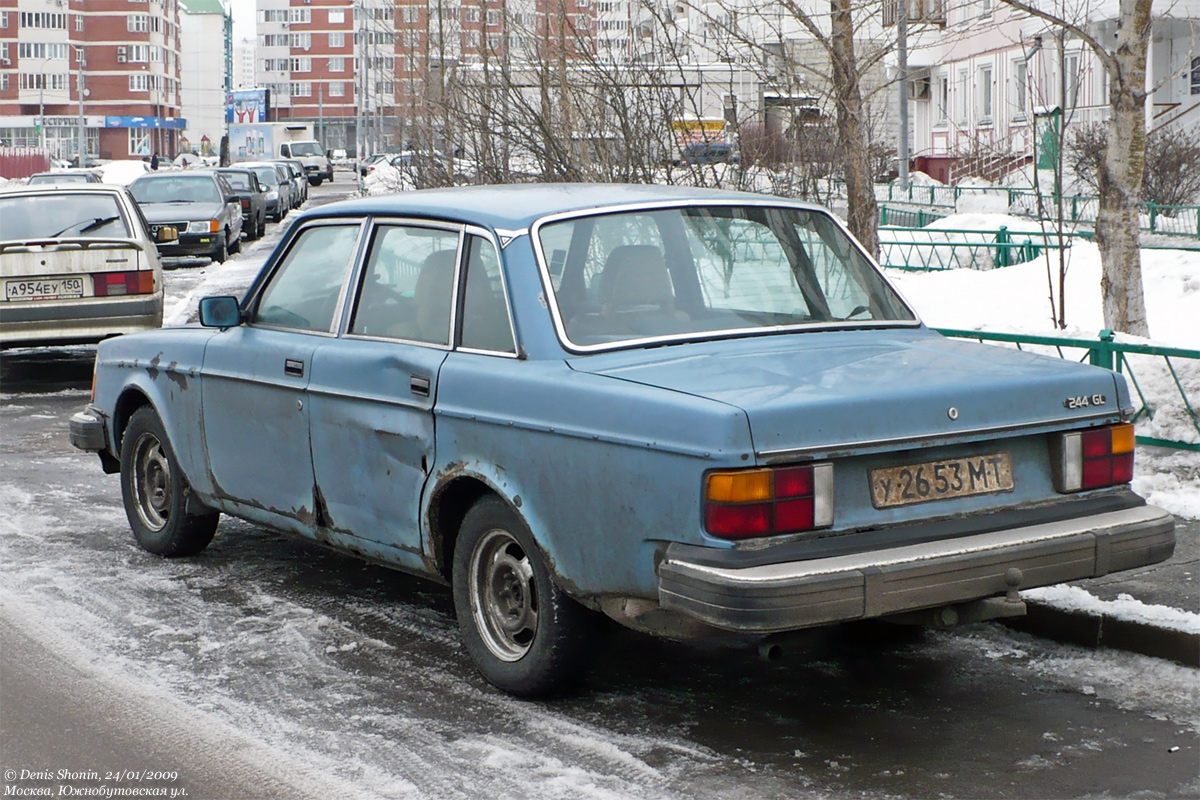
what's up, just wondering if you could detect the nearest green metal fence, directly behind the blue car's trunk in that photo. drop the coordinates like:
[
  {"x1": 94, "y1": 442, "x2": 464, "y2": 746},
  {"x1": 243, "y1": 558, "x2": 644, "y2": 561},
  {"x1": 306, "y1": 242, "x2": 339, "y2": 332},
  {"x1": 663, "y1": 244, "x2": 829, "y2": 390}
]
[{"x1": 937, "y1": 327, "x2": 1200, "y2": 452}]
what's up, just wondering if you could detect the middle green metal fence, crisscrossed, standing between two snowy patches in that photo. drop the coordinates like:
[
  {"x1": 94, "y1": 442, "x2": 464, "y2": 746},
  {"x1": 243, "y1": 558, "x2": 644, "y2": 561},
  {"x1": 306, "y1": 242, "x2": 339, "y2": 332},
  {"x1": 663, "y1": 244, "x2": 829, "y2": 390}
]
[{"x1": 880, "y1": 225, "x2": 1078, "y2": 272}]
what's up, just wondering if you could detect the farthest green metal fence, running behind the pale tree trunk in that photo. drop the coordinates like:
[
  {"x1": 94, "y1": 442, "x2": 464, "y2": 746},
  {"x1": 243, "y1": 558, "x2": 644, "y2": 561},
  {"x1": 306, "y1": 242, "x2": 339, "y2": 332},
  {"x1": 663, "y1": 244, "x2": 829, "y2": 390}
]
[{"x1": 854, "y1": 181, "x2": 1200, "y2": 239}]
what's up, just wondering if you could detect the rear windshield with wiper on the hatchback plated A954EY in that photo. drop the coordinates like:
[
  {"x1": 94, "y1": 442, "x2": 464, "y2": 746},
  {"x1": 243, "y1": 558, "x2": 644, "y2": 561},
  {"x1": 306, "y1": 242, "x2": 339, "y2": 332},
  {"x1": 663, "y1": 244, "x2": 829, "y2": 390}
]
[{"x1": 0, "y1": 193, "x2": 130, "y2": 240}]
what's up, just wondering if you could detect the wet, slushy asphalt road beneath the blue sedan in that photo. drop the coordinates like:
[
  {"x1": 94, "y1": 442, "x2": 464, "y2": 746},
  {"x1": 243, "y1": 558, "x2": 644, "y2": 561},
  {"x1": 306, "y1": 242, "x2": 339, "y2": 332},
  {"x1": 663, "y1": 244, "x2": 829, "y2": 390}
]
[{"x1": 0, "y1": 175, "x2": 1200, "y2": 800}]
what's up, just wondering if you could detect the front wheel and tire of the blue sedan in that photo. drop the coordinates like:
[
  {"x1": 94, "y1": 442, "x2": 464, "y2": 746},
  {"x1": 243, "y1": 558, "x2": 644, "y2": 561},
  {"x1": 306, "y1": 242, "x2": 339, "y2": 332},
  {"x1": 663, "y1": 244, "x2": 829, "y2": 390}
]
[{"x1": 121, "y1": 405, "x2": 221, "y2": 558}]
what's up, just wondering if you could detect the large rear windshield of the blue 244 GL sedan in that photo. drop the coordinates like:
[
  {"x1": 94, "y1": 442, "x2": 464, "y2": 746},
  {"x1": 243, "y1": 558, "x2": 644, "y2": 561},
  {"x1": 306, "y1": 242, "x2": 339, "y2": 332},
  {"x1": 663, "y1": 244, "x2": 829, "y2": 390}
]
[{"x1": 538, "y1": 205, "x2": 916, "y2": 349}]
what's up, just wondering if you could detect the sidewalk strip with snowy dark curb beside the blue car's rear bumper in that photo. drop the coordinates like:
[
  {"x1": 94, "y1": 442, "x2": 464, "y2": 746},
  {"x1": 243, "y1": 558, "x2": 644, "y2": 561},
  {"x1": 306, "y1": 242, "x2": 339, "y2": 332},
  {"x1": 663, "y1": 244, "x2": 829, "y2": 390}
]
[{"x1": 1007, "y1": 519, "x2": 1200, "y2": 667}]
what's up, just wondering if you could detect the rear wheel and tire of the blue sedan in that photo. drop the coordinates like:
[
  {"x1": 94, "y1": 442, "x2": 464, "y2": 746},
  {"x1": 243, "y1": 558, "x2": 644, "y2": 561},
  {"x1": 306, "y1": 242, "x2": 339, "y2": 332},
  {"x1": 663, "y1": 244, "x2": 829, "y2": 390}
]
[{"x1": 451, "y1": 497, "x2": 598, "y2": 697}]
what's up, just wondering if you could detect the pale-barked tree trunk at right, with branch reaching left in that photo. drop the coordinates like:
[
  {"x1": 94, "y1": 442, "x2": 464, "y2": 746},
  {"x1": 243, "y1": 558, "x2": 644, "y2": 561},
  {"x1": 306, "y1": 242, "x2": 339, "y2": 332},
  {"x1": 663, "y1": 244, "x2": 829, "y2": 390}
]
[{"x1": 1001, "y1": 0, "x2": 1153, "y2": 336}]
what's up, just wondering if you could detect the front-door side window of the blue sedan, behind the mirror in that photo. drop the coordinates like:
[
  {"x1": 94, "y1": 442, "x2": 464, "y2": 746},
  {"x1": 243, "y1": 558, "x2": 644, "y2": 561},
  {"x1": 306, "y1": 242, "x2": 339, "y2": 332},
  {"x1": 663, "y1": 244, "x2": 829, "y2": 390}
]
[{"x1": 252, "y1": 224, "x2": 359, "y2": 332}]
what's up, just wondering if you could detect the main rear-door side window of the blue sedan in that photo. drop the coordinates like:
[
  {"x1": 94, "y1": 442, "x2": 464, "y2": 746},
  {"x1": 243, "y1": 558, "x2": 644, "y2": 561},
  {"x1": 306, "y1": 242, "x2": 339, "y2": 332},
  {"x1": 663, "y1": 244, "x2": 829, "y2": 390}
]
[{"x1": 349, "y1": 225, "x2": 458, "y2": 345}]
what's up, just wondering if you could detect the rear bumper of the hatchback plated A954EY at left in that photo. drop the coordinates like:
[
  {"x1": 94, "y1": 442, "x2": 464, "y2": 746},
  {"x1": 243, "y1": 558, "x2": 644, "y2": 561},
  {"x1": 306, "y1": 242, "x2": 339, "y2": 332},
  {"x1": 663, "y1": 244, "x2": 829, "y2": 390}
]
[{"x1": 0, "y1": 293, "x2": 162, "y2": 347}]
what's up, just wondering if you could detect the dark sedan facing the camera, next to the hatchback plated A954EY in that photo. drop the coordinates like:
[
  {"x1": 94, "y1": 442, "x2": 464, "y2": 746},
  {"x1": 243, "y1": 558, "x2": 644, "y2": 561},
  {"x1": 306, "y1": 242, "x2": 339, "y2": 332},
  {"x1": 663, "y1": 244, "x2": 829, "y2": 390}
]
[{"x1": 130, "y1": 169, "x2": 242, "y2": 264}]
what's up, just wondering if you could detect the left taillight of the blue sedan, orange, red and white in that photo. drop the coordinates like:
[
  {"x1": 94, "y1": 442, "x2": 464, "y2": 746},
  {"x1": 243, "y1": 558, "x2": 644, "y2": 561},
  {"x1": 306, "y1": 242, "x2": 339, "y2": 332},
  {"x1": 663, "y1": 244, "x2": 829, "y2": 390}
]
[{"x1": 704, "y1": 463, "x2": 833, "y2": 539}]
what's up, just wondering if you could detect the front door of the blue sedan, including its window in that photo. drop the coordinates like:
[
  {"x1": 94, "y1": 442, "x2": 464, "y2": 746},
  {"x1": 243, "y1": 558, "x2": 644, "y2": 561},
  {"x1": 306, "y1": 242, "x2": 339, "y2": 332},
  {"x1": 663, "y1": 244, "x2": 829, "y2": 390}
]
[{"x1": 202, "y1": 219, "x2": 361, "y2": 533}]
